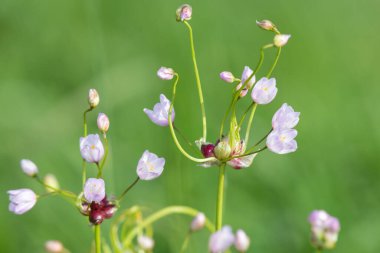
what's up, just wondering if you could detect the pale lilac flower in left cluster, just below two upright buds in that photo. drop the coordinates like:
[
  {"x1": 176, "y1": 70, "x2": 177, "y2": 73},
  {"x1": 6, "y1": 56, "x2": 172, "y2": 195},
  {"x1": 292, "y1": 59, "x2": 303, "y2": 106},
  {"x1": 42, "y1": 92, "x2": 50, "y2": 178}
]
[{"x1": 79, "y1": 134, "x2": 104, "y2": 163}]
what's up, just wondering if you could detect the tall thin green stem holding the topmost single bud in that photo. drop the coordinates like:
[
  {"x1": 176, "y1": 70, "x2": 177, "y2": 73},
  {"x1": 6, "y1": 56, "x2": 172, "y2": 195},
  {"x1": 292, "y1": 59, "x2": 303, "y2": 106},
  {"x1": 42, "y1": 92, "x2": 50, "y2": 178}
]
[{"x1": 183, "y1": 20, "x2": 207, "y2": 140}]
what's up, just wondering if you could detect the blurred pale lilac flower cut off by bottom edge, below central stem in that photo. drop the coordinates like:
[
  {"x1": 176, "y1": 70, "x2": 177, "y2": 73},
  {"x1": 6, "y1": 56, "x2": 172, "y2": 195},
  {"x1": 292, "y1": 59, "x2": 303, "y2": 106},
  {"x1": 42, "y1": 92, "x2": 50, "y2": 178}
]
[{"x1": 208, "y1": 226, "x2": 235, "y2": 253}]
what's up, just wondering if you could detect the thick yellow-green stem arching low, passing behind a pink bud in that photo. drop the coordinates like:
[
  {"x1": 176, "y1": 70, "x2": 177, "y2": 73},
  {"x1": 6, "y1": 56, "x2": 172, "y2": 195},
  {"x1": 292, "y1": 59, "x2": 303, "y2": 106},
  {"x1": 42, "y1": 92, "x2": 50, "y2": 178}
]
[{"x1": 123, "y1": 206, "x2": 214, "y2": 248}]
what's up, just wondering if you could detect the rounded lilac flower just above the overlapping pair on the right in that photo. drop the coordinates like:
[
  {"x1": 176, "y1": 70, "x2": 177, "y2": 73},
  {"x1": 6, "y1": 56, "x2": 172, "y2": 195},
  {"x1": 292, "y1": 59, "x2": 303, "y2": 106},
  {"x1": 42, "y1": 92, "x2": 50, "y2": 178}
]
[{"x1": 251, "y1": 77, "x2": 277, "y2": 105}]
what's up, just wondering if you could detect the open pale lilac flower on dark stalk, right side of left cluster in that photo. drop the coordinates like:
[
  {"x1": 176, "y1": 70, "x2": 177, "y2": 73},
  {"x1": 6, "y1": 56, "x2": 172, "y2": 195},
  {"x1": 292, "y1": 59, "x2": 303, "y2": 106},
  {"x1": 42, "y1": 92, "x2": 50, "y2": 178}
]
[{"x1": 137, "y1": 150, "x2": 165, "y2": 180}]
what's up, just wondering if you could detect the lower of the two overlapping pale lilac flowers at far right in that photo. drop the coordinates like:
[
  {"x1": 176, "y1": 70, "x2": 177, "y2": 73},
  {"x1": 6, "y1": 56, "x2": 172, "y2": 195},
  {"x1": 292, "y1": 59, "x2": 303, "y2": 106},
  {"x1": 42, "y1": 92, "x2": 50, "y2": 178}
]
[{"x1": 267, "y1": 129, "x2": 297, "y2": 154}]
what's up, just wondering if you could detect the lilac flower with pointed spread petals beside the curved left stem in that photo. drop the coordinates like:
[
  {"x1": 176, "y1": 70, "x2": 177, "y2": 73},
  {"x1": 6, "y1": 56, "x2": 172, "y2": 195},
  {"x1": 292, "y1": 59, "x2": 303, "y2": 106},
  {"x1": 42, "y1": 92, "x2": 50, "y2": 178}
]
[{"x1": 144, "y1": 94, "x2": 175, "y2": 126}]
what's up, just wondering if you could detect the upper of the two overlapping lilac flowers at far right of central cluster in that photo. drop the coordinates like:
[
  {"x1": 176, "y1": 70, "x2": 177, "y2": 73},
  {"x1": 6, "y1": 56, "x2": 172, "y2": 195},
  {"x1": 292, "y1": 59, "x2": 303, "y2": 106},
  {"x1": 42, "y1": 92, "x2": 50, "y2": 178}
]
[{"x1": 272, "y1": 103, "x2": 300, "y2": 130}]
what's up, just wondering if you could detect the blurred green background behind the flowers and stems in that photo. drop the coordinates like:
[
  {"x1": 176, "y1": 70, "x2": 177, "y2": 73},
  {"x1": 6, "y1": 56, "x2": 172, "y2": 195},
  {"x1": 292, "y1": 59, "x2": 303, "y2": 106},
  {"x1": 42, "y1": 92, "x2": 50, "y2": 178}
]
[{"x1": 0, "y1": 0, "x2": 380, "y2": 253}]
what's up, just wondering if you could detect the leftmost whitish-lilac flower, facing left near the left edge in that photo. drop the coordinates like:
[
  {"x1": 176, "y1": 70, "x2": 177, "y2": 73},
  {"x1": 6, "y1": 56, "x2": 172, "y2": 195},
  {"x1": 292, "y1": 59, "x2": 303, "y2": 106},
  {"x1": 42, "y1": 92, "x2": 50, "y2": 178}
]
[{"x1": 8, "y1": 189, "x2": 37, "y2": 214}]
